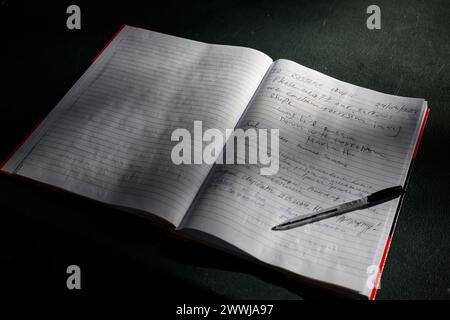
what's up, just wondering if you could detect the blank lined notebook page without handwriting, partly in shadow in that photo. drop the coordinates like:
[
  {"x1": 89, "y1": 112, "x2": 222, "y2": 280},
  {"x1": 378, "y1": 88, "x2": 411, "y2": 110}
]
[{"x1": 6, "y1": 27, "x2": 272, "y2": 226}]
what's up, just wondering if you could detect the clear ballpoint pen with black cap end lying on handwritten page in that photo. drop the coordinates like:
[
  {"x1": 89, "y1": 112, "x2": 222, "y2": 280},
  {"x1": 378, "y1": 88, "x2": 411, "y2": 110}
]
[{"x1": 272, "y1": 186, "x2": 405, "y2": 231}]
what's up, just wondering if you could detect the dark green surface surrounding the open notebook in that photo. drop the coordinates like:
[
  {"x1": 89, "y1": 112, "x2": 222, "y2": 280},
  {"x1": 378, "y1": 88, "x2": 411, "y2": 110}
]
[{"x1": 0, "y1": 0, "x2": 450, "y2": 299}]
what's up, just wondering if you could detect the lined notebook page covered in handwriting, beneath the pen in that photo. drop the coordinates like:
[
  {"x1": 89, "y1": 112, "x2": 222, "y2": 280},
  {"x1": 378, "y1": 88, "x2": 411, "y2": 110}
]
[{"x1": 185, "y1": 60, "x2": 425, "y2": 296}]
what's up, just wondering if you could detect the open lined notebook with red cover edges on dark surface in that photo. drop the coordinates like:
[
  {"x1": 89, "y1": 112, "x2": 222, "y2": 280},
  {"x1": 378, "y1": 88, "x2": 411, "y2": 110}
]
[{"x1": 2, "y1": 26, "x2": 429, "y2": 298}]
